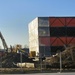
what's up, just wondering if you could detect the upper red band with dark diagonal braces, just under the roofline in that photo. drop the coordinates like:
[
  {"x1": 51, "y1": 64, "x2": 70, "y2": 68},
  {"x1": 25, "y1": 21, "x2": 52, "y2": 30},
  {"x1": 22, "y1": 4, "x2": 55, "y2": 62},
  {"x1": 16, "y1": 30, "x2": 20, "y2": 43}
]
[{"x1": 49, "y1": 17, "x2": 75, "y2": 27}]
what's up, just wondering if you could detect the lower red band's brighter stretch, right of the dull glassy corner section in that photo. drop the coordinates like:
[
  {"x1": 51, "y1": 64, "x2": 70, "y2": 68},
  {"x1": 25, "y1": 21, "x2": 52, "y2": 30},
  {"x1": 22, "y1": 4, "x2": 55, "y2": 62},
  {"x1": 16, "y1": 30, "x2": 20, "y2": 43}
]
[{"x1": 50, "y1": 37, "x2": 75, "y2": 46}]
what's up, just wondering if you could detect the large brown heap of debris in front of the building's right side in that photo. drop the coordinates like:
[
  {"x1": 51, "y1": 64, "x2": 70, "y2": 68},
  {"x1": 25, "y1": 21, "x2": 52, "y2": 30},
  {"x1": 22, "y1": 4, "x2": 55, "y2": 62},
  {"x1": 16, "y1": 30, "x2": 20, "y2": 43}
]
[{"x1": 46, "y1": 45, "x2": 75, "y2": 68}]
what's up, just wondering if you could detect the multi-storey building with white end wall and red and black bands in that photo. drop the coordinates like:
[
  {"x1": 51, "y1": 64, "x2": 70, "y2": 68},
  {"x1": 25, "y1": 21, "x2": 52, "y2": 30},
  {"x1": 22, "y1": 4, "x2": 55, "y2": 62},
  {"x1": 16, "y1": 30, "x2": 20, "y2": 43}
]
[{"x1": 29, "y1": 17, "x2": 75, "y2": 56}]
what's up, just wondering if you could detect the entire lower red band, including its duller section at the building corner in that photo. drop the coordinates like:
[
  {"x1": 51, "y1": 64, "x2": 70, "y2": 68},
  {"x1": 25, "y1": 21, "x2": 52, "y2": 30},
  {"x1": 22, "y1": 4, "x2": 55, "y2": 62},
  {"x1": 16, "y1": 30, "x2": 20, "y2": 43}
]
[{"x1": 39, "y1": 37, "x2": 75, "y2": 46}]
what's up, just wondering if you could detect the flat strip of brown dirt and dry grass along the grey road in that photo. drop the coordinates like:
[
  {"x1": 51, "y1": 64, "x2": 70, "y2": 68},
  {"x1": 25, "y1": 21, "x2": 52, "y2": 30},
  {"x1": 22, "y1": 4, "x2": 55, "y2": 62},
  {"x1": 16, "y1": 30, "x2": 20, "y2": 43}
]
[{"x1": 0, "y1": 68, "x2": 75, "y2": 74}]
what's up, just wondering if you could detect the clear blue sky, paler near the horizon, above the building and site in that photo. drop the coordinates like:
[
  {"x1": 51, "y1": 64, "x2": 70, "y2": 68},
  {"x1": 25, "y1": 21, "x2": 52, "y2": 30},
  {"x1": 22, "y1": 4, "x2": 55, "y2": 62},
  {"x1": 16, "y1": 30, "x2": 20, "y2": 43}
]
[{"x1": 0, "y1": 0, "x2": 75, "y2": 46}]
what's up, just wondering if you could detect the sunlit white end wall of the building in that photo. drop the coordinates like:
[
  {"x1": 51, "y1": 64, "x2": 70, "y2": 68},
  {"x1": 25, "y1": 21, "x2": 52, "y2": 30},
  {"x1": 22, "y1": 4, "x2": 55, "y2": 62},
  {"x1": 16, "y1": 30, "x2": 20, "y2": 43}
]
[{"x1": 29, "y1": 18, "x2": 39, "y2": 53}]
